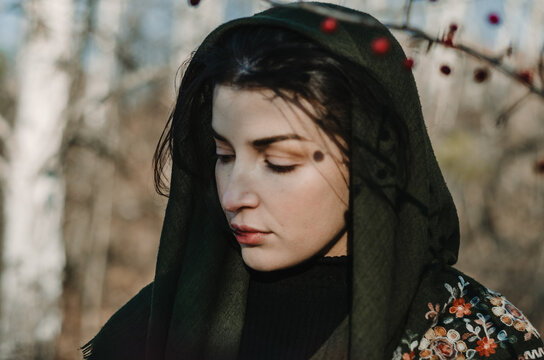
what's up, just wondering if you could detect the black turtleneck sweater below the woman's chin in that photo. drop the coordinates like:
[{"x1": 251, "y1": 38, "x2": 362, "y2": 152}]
[{"x1": 239, "y1": 255, "x2": 351, "y2": 360}]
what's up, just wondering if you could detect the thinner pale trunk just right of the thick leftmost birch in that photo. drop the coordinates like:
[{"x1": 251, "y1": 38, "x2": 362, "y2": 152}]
[{"x1": 78, "y1": 0, "x2": 125, "y2": 339}]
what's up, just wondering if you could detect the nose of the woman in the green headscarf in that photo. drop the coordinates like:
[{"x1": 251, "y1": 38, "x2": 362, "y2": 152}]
[{"x1": 221, "y1": 161, "x2": 259, "y2": 213}]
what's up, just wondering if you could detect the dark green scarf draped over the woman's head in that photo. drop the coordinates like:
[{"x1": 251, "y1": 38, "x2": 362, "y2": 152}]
[{"x1": 85, "y1": 3, "x2": 459, "y2": 360}]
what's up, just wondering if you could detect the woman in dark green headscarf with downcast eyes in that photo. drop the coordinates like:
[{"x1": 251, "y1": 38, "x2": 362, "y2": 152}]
[{"x1": 84, "y1": 4, "x2": 544, "y2": 360}]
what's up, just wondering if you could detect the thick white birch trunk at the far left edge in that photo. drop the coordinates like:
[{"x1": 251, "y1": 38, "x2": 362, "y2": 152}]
[{"x1": 0, "y1": 0, "x2": 73, "y2": 359}]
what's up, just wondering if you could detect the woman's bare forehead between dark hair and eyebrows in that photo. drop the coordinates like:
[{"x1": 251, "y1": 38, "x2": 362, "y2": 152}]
[{"x1": 212, "y1": 85, "x2": 323, "y2": 142}]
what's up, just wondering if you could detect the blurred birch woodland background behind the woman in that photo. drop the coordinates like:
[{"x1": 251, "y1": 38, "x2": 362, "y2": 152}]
[{"x1": 0, "y1": 0, "x2": 544, "y2": 360}]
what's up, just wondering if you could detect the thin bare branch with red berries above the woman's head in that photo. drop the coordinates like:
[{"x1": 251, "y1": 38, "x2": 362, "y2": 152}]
[{"x1": 264, "y1": 0, "x2": 544, "y2": 99}]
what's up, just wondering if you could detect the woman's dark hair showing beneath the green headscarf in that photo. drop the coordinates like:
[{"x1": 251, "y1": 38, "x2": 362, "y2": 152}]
[{"x1": 154, "y1": 26, "x2": 407, "y2": 200}]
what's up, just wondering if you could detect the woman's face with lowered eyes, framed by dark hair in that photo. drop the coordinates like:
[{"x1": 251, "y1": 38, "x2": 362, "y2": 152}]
[{"x1": 212, "y1": 85, "x2": 349, "y2": 271}]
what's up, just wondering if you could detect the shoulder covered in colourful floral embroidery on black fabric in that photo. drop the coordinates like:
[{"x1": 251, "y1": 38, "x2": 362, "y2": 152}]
[{"x1": 394, "y1": 273, "x2": 544, "y2": 360}]
